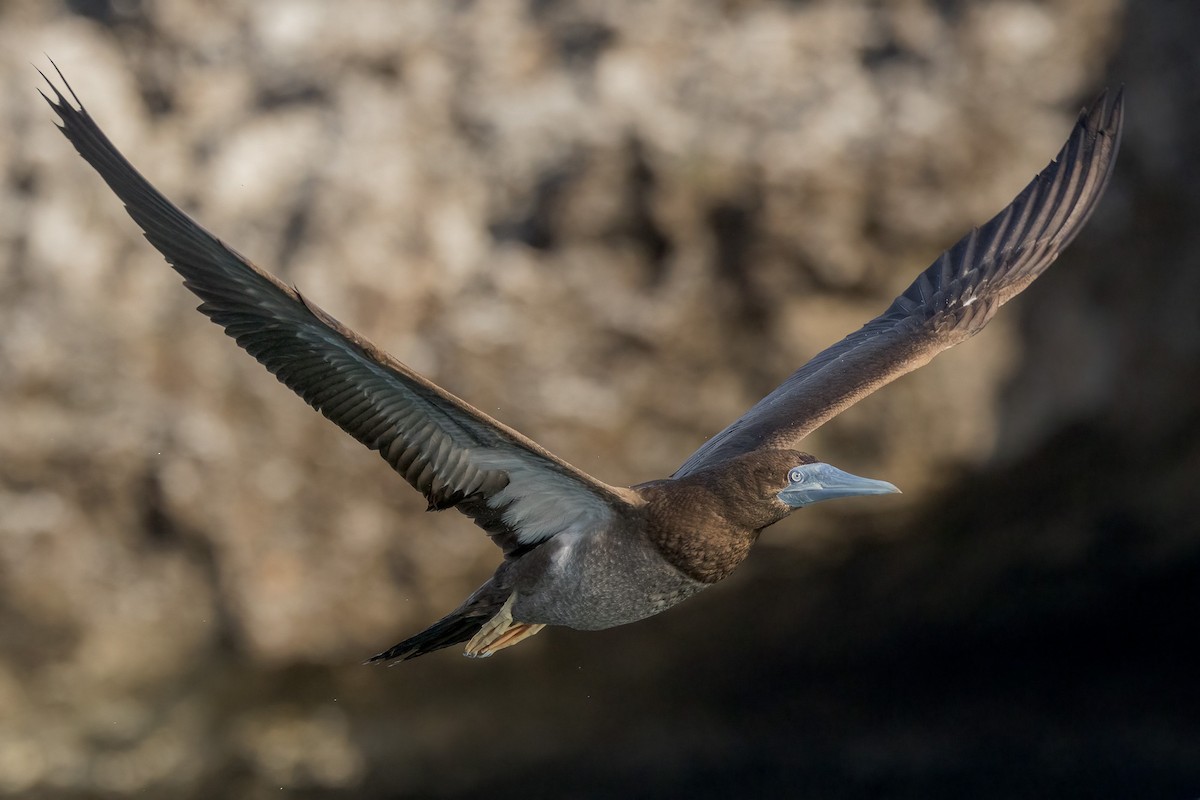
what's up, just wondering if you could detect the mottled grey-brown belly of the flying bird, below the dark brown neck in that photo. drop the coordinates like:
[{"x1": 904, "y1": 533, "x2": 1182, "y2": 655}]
[{"x1": 512, "y1": 534, "x2": 709, "y2": 631}]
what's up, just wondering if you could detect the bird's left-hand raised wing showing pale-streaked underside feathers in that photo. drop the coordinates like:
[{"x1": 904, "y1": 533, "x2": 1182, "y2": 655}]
[{"x1": 42, "y1": 66, "x2": 631, "y2": 555}]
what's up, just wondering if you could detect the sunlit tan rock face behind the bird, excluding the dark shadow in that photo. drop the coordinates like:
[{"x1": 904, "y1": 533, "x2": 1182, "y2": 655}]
[{"x1": 9, "y1": 0, "x2": 1195, "y2": 796}]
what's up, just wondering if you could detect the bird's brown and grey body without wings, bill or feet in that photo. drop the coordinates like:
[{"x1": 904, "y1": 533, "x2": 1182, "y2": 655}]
[{"x1": 378, "y1": 450, "x2": 806, "y2": 660}]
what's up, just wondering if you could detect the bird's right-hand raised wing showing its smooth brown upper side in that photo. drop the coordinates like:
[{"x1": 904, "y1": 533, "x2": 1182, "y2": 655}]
[{"x1": 674, "y1": 91, "x2": 1123, "y2": 477}]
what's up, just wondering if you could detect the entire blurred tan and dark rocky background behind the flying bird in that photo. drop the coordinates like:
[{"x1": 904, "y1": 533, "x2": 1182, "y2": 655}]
[{"x1": 0, "y1": 0, "x2": 1200, "y2": 799}]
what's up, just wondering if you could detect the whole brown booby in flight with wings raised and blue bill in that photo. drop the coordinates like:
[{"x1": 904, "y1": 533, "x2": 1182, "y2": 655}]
[{"x1": 42, "y1": 67, "x2": 1123, "y2": 662}]
